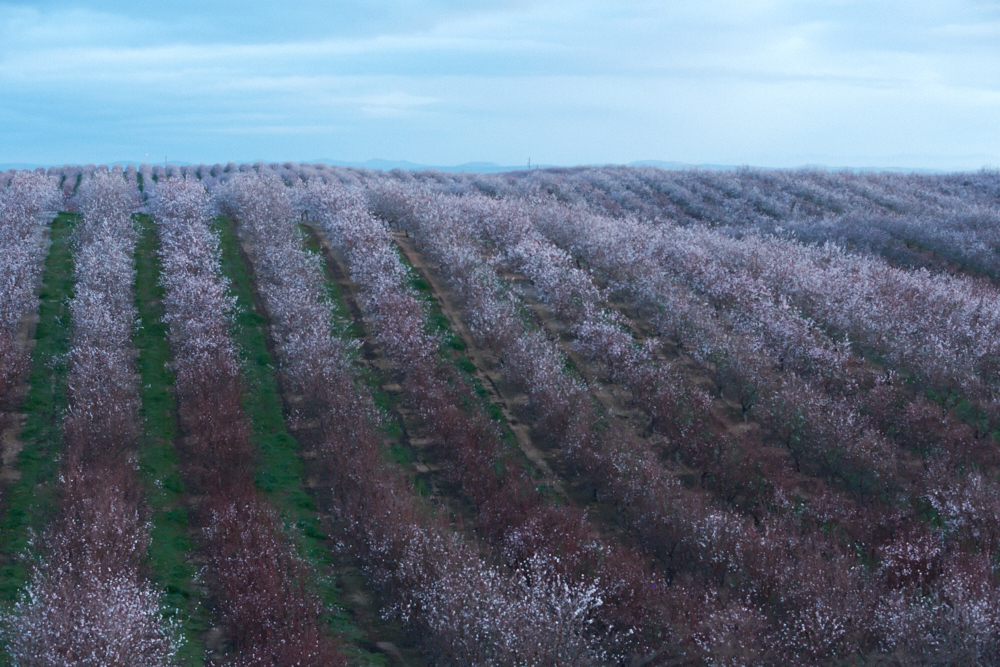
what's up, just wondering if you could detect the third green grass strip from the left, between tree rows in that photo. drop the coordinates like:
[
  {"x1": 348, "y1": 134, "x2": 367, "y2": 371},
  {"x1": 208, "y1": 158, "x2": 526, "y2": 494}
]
[{"x1": 214, "y1": 217, "x2": 383, "y2": 664}]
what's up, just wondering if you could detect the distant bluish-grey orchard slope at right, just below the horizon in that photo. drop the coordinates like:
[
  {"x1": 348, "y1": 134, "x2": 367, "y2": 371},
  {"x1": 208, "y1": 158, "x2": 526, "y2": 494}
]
[{"x1": 516, "y1": 168, "x2": 1000, "y2": 277}]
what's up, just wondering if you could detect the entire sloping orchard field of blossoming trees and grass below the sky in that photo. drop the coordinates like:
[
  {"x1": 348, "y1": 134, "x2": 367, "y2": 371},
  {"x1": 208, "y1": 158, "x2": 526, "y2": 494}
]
[{"x1": 0, "y1": 163, "x2": 1000, "y2": 666}]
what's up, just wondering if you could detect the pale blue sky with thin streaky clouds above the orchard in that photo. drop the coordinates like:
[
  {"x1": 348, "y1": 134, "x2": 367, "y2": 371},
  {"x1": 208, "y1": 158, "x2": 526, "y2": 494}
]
[{"x1": 0, "y1": 0, "x2": 1000, "y2": 170}]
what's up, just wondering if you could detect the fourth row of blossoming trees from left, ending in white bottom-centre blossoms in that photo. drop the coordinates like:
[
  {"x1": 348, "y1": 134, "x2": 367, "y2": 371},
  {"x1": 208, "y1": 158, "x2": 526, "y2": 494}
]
[{"x1": 221, "y1": 177, "x2": 632, "y2": 665}]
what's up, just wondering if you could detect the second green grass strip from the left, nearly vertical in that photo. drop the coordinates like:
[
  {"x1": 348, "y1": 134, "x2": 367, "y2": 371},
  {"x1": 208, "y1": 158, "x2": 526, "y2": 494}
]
[{"x1": 133, "y1": 215, "x2": 208, "y2": 666}]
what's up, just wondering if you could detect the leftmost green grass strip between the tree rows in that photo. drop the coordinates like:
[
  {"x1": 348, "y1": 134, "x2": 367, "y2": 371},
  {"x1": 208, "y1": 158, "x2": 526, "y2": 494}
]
[{"x1": 0, "y1": 213, "x2": 80, "y2": 664}]
